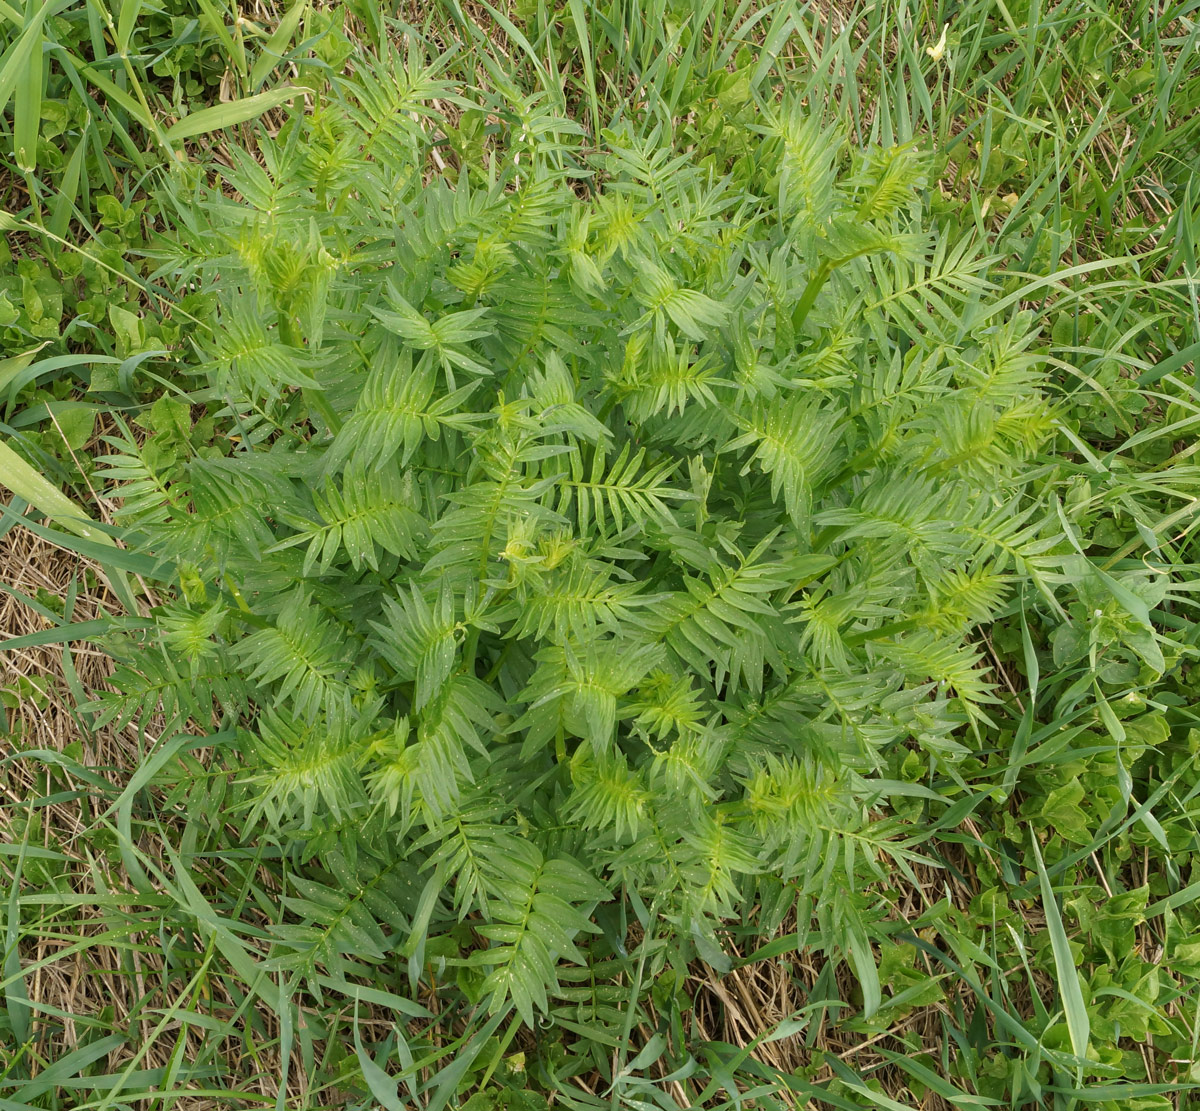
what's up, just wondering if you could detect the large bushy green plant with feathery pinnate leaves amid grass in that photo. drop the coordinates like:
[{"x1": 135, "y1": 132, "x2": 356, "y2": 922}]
[{"x1": 98, "y1": 41, "x2": 1080, "y2": 1069}]
